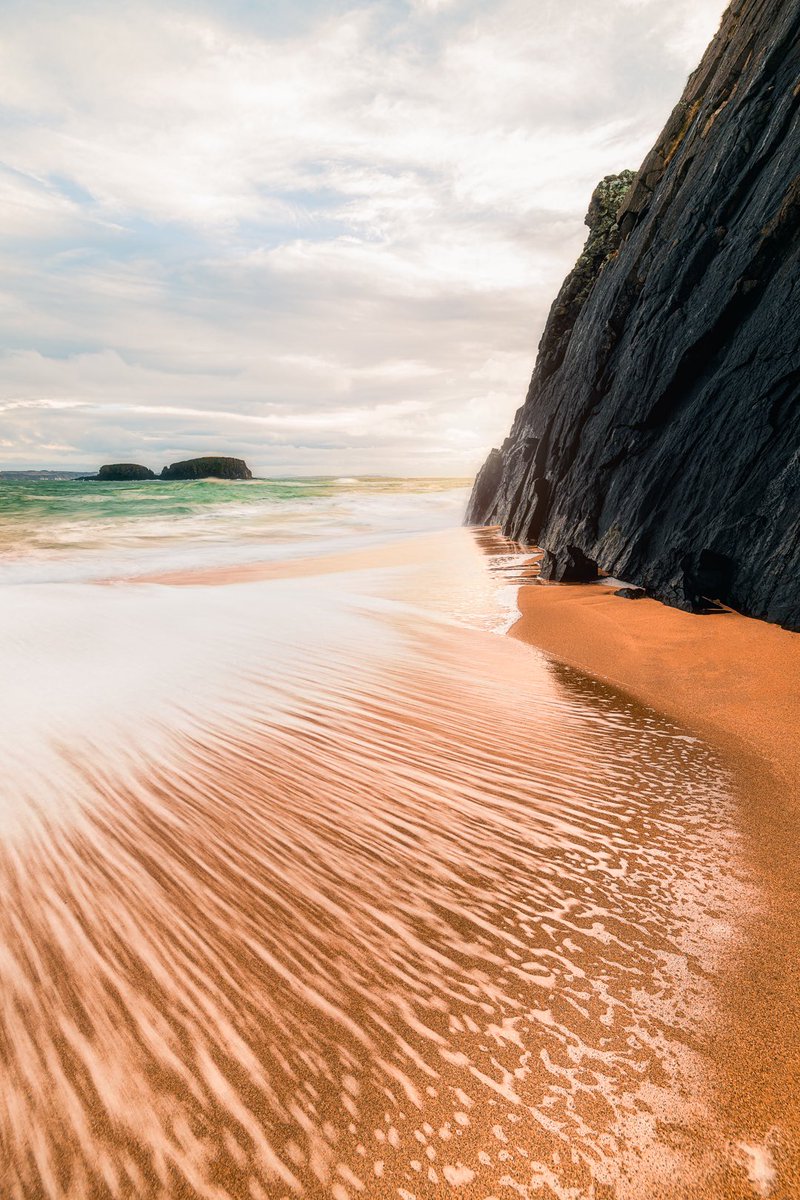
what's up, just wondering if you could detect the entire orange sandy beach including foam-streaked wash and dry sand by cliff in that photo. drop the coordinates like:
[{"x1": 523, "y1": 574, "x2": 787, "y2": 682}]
[{"x1": 0, "y1": 489, "x2": 798, "y2": 1200}]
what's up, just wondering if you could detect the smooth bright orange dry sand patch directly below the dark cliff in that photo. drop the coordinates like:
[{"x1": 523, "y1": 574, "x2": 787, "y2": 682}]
[{"x1": 512, "y1": 582, "x2": 800, "y2": 800}]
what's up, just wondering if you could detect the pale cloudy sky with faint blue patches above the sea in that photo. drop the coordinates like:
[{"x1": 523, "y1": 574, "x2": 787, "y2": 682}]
[{"x1": 0, "y1": 0, "x2": 724, "y2": 475}]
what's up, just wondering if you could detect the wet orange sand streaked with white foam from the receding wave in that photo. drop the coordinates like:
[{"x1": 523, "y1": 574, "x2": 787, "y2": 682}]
[{"x1": 0, "y1": 540, "x2": 753, "y2": 1200}]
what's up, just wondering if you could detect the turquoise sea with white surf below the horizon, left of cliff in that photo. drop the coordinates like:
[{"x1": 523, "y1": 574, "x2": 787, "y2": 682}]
[{"x1": 0, "y1": 476, "x2": 469, "y2": 583}]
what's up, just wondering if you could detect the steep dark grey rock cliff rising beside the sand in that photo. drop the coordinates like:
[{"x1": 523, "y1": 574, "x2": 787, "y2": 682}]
[{"x1": 467, "y1": 0, "x2": 800, "y2": 630}]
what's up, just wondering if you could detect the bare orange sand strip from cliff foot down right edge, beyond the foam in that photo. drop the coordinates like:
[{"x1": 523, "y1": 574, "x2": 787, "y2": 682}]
[{"x1": 509, "y1": 581, "x2": 800, "y2": 1196}]
